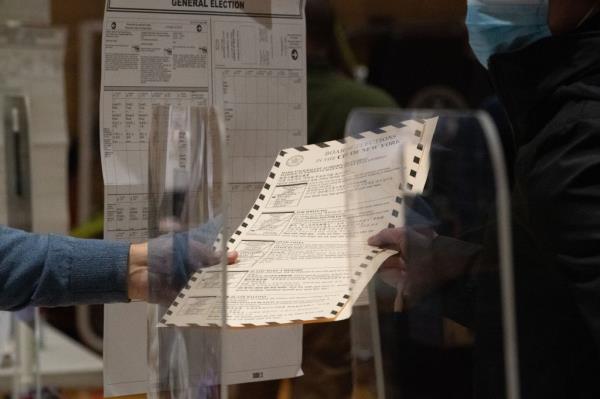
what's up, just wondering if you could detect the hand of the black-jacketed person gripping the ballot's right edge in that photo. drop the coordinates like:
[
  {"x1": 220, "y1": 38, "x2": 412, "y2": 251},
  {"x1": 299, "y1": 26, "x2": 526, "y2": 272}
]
[{"x1": 368, "y1": 226, "x2": 438, "y2": 312}]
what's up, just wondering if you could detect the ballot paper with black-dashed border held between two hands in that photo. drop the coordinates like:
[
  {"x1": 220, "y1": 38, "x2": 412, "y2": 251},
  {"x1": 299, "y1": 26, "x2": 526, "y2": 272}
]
[{"x1": 161, "y1": 118, "x2": 437, "y2": 327}]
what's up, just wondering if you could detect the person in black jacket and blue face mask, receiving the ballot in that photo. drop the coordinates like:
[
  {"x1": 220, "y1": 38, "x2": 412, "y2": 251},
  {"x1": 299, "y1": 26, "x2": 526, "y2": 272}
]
[{"x1": 370, "y1": 0, "x2": 600, "y2": 399}]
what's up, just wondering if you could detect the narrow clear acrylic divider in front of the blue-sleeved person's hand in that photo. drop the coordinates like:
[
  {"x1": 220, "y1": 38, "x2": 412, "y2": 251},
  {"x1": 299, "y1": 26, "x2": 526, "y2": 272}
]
[{"x1": 148, "y1": 106, "x2": 229, "y2": 399}]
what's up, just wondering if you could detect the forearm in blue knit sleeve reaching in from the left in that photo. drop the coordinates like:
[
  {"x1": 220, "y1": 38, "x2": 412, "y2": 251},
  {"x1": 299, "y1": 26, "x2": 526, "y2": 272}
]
[{"x1": 0, "y1": 226, "x2": 129, "y2": 310}]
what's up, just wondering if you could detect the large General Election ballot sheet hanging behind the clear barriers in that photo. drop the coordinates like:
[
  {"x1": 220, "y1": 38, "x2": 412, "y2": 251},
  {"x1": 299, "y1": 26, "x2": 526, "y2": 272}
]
[{"x1": 100, "y1": 0, "x2": 307, "y2": 396}]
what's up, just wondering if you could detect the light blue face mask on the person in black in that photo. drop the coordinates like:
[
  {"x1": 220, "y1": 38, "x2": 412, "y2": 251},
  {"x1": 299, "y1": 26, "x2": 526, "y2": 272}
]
[{"x1": 466, "y1": 0, "x2": 551, "y2": 67}]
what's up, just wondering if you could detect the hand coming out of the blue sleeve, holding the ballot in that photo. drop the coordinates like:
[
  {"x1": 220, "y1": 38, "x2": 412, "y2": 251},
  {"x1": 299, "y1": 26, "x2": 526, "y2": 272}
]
[{"x1": 127, "y1": 237, "x2": 238, "y2": 301}]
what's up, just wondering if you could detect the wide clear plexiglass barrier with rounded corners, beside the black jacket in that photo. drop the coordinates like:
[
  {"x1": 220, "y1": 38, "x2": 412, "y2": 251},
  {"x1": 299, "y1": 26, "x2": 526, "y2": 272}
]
[{"x1": 346, "y1": 109, "x2": 519, "y2": 399}]
